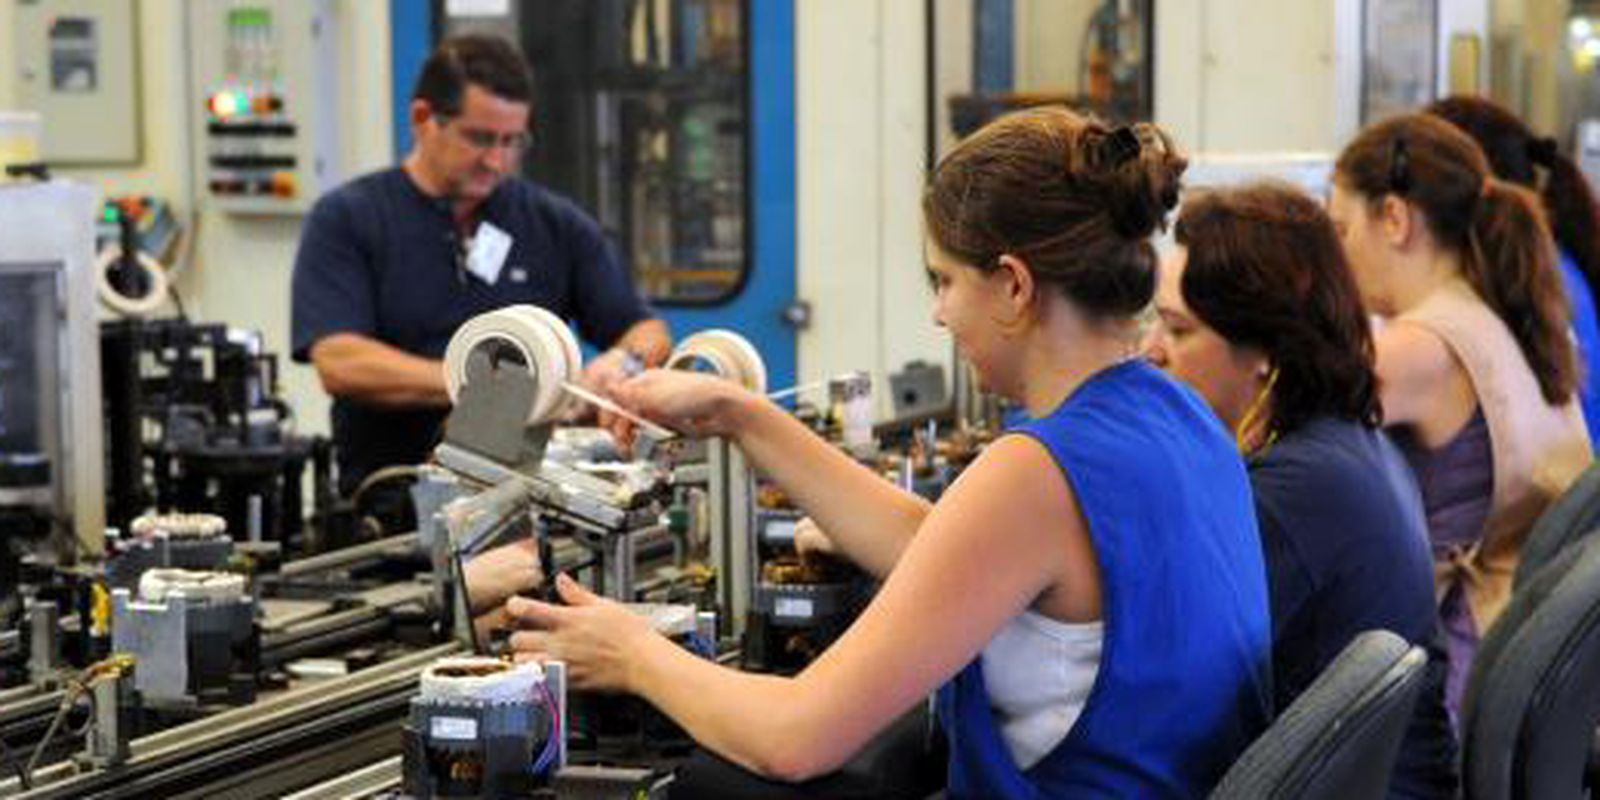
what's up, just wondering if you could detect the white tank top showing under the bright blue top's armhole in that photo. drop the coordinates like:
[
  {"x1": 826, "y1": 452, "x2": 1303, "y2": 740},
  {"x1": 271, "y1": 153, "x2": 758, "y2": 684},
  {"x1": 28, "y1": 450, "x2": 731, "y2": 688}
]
[{"x1": 982, "y1": 611, "x2": 1104, "y2": 770}]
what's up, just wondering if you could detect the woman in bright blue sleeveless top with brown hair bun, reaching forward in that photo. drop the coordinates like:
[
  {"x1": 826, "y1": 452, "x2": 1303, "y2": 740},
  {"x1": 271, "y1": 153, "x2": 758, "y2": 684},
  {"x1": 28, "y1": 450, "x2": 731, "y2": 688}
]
[{"x1": 509, "y1": 109, "x2": 1270, "y2": 798}]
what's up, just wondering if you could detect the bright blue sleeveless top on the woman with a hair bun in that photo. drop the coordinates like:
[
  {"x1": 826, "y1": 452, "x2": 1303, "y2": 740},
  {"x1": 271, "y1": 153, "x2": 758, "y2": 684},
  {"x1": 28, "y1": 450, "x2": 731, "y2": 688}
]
[{"x1": 938, "y1": 362, "x2": 1272, "y2": 798}]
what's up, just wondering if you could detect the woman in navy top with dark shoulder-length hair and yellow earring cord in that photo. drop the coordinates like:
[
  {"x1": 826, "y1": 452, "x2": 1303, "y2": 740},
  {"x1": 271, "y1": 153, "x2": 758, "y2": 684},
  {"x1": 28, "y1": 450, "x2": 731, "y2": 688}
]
[{"x1": 1150, "y1": 184, "x2": 1456, "y2": 797}]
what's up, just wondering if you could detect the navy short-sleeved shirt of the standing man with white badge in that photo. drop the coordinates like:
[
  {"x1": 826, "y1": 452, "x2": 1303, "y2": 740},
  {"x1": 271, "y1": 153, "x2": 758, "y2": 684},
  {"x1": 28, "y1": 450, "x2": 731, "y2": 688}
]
[{"x1": 293, "y1": 166, "x2": 650, "y2": 491}]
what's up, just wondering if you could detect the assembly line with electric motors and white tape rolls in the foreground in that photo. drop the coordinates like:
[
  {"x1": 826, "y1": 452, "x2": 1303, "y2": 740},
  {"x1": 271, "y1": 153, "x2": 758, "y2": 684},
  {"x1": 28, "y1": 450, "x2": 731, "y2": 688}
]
[{"x1": 0, "y1": 292, "x2": 972, "y2": 798}]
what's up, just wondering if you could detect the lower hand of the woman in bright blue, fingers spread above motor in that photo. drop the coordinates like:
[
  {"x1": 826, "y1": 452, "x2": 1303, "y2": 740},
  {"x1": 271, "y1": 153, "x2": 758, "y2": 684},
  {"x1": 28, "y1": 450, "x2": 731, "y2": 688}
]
[{"x1": 506, "y1": 574, "x2": 658, "y2": 691}]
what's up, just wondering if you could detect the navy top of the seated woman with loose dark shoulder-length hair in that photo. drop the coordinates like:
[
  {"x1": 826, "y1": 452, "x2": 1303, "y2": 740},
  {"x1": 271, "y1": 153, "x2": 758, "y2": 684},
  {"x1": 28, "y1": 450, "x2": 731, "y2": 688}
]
[{"x1": 1250, "y1": 418, "x2": 1456, "y2": 798}]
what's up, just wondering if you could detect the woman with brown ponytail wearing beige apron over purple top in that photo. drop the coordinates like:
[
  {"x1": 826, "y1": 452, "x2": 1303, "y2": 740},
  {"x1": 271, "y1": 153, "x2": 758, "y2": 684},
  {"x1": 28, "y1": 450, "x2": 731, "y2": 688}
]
[{"x1": 1328, "y1": 114, "x2": 1590, "y2": 720}]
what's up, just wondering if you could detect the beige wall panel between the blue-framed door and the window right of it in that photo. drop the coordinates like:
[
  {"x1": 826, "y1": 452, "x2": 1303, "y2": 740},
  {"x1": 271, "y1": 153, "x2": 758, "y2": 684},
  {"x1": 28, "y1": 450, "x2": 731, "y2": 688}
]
[{"x1": 795, "y1": 0, "x2": 952, "y2": 416}]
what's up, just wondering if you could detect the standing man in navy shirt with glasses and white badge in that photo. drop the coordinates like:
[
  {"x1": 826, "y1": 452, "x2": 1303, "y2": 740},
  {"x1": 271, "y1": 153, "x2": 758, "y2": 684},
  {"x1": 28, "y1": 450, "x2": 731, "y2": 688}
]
[{"x1": 293, "y1": 35, "x2": 672, "y2": 494}]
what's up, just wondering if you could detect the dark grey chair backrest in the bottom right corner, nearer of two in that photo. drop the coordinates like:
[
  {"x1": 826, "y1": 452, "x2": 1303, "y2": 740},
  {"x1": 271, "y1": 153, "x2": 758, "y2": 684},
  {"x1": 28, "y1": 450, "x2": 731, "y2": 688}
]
[{"x1": 1461, "y1": 536, "x2": 1600, "y2": 800}]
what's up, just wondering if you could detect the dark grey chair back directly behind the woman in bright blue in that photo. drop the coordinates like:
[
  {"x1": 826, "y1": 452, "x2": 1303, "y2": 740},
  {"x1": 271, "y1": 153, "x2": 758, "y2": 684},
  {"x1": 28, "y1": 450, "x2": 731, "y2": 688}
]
[{"x1": 1211, "y1": 630, "x2": 1427, "y2": 800}]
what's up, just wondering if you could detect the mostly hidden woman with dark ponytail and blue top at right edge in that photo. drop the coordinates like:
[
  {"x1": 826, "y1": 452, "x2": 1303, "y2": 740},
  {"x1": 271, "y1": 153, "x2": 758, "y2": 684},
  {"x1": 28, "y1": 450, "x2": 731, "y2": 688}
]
[{"x1": 1427, "y1": 94, "x2": 1600, "y2": 438}]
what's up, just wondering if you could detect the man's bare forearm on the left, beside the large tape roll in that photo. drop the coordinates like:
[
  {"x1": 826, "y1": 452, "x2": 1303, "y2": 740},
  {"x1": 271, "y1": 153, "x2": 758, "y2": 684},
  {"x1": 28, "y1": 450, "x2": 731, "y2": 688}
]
[{"x1": 310, "y1": 333, "x2": 450, "y2": 408}]
